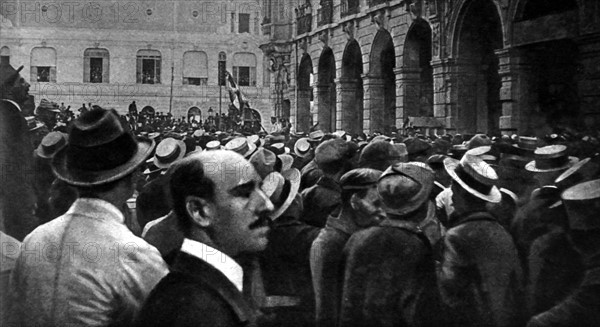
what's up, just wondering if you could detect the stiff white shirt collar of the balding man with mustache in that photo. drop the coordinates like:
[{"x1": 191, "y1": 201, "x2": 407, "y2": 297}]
[{"x1": 181, "y1": 238, "x2": 244, "y2": 292}]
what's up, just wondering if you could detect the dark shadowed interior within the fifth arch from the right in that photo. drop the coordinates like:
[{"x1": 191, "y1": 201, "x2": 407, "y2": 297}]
[{"x1": 342, "y1": 40, "x2": 364, "y2": 133}]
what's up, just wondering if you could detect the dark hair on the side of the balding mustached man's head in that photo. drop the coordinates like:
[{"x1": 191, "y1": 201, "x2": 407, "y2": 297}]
[{"x1": 169, "y1": 157, "x2": 215, "y2": 233}]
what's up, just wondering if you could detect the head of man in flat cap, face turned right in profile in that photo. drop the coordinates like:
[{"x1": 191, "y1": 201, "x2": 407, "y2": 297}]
[{"x1": 340, "y1": 168, "x2": 385, "y2": 227}]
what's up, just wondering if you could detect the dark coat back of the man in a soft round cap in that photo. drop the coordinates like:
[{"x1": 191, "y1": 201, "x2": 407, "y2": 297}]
[{"x1": 339, "y1": 219, "x2": 443, "y2": 326}]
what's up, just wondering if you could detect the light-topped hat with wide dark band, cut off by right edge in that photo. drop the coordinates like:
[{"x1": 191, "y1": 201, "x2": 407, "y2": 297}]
[{"x1": 561, "y1": 179, "x2": 600, "y2": 230}]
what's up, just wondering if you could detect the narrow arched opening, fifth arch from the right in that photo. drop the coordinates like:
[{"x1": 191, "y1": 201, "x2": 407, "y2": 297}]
[{"x1": 341, "y1": 40, "x2": 364, "y2": 134}]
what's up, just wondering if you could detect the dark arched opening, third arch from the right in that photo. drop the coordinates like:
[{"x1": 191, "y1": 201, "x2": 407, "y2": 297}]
[{"x1": 401, "y1": 19, "x2": 433, "y2": 117}]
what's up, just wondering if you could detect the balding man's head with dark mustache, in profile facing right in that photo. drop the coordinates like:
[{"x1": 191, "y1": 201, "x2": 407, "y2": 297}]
[{"x1": 170, "y1": 150, "x2": 273, "y2": 256}]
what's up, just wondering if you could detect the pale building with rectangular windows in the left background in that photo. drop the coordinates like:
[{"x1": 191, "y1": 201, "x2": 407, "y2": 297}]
[{"x1": 0, "y1": 0, "x2": 272, "y2": 124}]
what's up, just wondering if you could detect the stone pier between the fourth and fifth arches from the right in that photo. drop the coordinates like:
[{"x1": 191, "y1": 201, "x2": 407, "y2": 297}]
[{"x1": 362, "y1": 75, "x2": 386, "y2": 133}]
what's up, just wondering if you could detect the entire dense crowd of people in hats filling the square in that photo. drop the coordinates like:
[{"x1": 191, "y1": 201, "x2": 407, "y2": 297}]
[{"x1": 0, "y1": 59, "x2": 600, "y2": 327}]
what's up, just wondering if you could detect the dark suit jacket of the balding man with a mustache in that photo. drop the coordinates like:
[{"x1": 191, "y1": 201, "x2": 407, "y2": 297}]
[{"x1": 138, "y1": 251, "x2": 256, "y2": 327}]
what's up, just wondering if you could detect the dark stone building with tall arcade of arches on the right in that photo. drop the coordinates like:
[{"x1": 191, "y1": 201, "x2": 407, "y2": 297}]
[{"x1": 261, "y1": 0, "x2": 600, "y2": 135}]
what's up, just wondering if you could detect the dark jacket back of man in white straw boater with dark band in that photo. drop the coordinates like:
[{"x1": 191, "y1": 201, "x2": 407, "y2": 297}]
[{"x1": 438, "y1": 212, "x2": 524, "y2": 327}]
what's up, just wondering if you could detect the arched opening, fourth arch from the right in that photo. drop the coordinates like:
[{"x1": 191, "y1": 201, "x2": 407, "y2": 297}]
[{"x1": 369, "y1": 30, "x2": 396, "y2": 135}]
